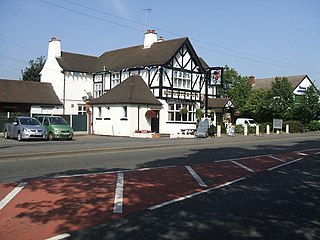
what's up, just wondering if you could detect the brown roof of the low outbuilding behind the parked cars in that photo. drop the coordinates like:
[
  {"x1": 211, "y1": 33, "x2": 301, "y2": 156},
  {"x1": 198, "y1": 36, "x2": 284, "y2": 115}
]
[{"x1": 0, "y1": 79, "x2": 62, "y2": 105}]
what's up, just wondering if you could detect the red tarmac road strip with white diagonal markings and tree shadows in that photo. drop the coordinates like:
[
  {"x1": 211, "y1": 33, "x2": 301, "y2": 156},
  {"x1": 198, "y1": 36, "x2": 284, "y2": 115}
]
[{"x1": 0, "y1": 149, "x2": 320, "y2": 240}]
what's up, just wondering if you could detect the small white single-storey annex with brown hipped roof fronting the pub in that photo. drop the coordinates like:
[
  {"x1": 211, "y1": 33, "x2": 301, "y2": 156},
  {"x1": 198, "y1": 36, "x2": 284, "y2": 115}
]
[{"x1": 91, "y1": 74, "x2": 162, "y2": 136}]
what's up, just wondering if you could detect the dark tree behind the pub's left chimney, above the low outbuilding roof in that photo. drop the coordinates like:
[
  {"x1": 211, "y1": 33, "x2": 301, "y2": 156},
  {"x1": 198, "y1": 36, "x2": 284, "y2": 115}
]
[{"x1": 21, "y1": 56, "x2": 46, "y2": 82}]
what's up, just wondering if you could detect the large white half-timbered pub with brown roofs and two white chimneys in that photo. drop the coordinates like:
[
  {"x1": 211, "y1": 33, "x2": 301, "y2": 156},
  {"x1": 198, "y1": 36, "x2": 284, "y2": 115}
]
[{"x1": 41, "y1": 30, "x2": 216, "y2": 136}]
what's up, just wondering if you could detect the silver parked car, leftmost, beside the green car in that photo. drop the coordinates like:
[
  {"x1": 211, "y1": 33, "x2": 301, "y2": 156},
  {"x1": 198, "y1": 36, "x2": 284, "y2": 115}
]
[{"x1": 3, "y1": 116, "x2": 47, "y2": 141}]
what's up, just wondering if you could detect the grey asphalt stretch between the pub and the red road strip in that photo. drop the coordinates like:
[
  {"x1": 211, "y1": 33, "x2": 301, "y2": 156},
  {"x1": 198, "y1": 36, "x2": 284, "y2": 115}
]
[{"x1": 0, "y1": 132, "x2": 320, "y2": 183}]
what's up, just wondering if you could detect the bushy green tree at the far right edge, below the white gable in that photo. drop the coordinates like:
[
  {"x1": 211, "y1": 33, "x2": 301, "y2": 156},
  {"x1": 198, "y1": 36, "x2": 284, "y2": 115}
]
[{"x1": 293, "y1": 86, "x2": 320, "y2": 125}]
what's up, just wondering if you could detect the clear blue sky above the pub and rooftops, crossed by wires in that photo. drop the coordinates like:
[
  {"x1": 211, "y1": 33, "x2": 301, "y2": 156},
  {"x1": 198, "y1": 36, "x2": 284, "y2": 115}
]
[{"x1": 0, "y1": 0, "x2": 320, "y2": 88}]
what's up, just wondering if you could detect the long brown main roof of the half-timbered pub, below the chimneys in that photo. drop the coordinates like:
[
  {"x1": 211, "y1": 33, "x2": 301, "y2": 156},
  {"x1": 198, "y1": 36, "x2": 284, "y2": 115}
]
[{"x1": 57, "y1": 37, "x2": 207, "y2": 73}]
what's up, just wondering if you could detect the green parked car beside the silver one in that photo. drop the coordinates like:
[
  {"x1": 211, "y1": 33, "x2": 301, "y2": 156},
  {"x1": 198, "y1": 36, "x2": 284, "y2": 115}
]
[{"x1": 36, "y1": 116, "x2": 73, "y2": 141}]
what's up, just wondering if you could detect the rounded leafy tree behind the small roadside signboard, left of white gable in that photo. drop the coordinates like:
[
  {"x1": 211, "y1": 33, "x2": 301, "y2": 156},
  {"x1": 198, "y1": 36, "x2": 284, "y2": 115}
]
[{"x1": 264, "y1": 78, "x2": 294, "y2": 121}]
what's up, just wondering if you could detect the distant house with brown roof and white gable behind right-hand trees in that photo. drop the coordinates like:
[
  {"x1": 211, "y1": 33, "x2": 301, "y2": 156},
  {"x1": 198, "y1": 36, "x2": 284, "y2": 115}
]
[{"x1": 248, "y1": 75, "x2": 317, "y2": 96}]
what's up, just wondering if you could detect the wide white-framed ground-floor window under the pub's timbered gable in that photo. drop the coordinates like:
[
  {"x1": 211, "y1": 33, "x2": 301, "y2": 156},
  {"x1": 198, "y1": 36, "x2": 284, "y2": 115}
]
[{"x1": 168, "y1": 104, "x2": 195, "y2": 122}]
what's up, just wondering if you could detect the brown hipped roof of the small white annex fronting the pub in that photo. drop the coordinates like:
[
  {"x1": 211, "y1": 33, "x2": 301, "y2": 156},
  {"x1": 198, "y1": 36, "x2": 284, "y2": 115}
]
[{"x1": 92, "y1": 75, "x2": 162, "y2": 105}]
